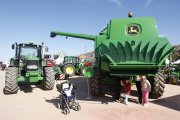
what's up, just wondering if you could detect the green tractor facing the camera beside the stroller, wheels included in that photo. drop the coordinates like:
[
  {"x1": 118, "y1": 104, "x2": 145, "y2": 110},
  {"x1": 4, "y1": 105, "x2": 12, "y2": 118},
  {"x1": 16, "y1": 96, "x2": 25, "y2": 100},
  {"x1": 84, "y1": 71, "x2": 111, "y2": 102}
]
[{"x1": 4, "y1": 42, "x2": 55, "y2": 94}]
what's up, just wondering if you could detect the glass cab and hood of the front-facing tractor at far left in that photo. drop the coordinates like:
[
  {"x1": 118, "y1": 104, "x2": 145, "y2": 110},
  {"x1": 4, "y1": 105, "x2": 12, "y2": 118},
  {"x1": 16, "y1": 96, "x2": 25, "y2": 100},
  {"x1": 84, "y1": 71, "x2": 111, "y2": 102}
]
[{"x1": 10, "y1": 42, "x2": 42, "y2": 71}]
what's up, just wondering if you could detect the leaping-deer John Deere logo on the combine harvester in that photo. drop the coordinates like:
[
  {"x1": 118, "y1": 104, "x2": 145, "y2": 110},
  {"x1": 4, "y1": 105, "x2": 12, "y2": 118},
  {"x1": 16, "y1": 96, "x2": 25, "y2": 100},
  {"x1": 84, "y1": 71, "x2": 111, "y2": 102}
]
[{"x1": 127, "y1": 25, "x2": 141, "y2": 35}]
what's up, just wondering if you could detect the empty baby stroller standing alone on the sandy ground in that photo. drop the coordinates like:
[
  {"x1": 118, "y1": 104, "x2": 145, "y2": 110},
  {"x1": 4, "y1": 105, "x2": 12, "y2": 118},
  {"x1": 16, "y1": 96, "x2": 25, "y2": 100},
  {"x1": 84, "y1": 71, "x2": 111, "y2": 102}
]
[{"x1": 56, "y1": 81, "x2": 81, "y2": 115}]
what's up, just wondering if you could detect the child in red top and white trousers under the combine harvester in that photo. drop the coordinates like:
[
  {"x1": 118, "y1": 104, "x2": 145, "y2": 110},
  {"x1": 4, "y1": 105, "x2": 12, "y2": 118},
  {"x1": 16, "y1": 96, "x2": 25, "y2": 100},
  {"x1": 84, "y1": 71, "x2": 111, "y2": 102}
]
[{"x1": 122, "y1": 80, "x2": 132, "y2": 105}]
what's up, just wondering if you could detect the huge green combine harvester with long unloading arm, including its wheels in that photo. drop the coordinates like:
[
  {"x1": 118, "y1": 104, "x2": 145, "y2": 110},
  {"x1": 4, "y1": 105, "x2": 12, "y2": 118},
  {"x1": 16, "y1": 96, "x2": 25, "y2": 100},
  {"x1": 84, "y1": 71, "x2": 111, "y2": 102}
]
[{"x1": 51, "y1": 13, "x2": 174, "y2": 98}]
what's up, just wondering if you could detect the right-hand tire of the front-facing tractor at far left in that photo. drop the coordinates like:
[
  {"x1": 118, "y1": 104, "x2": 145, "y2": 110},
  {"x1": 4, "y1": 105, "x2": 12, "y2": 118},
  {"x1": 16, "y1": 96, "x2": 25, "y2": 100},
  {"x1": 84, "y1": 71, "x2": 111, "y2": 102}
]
[{"x1": 43, "y1": 67, "x2": 55, "y2": 90}]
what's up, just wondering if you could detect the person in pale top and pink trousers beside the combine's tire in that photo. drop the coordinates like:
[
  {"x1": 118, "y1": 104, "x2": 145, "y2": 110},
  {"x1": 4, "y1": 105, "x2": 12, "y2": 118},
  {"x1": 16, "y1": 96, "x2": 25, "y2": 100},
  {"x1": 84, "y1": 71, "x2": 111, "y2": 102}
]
[{"x1": 141, "y1": 75, "x2": 151, "y2": 106}]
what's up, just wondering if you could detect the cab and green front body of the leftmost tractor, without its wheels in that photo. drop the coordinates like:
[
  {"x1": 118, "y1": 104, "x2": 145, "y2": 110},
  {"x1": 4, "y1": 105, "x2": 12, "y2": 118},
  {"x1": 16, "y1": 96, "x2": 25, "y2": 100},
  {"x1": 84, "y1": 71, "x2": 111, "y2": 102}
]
[{"x1": 10, "y1": 42, "x2": 50, "y2": 83}]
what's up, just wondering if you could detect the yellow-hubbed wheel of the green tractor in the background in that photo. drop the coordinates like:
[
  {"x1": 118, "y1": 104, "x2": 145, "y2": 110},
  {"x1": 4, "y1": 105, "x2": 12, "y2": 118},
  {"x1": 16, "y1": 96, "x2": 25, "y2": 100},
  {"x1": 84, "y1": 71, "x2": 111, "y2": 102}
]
[{"x1": 63, "y1": 64, "x2": 75, "y2": 76}]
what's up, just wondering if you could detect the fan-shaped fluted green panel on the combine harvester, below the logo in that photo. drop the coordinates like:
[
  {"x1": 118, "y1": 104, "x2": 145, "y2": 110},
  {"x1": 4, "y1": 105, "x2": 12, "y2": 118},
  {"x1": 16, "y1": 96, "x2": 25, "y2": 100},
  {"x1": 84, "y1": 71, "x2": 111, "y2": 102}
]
[{"x1": 95, "y1": 38, "x2": 173, "y2": 74}]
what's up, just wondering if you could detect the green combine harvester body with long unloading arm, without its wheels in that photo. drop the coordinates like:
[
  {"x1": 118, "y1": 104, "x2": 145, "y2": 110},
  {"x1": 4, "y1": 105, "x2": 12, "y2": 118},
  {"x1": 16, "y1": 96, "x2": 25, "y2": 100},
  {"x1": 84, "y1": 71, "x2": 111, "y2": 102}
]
[{"x1": 51, "y1": 17, "x2": 174, "y2": 75}]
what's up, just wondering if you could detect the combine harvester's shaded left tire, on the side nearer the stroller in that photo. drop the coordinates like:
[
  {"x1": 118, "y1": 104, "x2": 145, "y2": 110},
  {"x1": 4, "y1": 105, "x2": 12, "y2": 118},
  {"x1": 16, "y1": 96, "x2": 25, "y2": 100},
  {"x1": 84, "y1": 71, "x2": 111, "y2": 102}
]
[{"x1": 90, "y1": 68, "x2": 102, "y2": 96}]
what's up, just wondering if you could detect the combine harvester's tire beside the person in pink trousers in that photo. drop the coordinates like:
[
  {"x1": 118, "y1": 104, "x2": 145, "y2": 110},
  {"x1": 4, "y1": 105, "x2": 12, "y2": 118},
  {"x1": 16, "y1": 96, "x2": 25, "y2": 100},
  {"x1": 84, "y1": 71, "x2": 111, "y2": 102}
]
[{"x1": 150, "y1": 72, "x2": 165, "y2": 99}]
